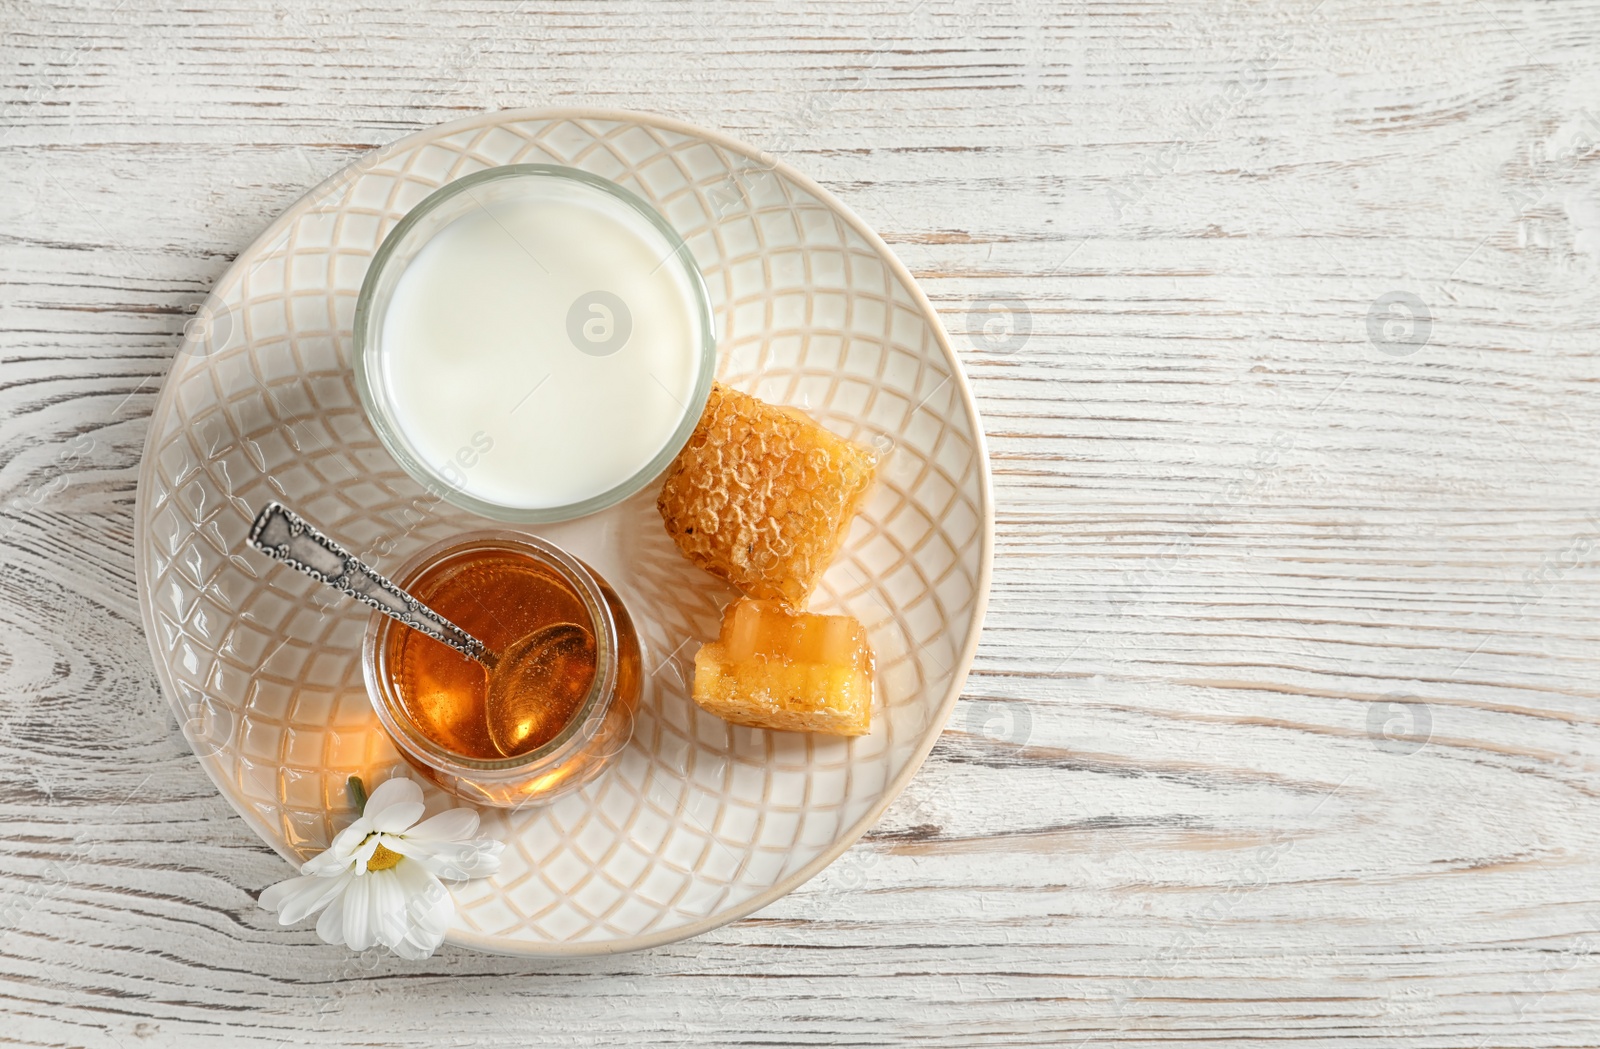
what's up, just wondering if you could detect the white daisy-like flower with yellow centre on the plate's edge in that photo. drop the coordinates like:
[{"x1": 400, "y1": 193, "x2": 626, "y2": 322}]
[{"x1": 261, "y1": 777, "x2": 506, "y2": 959}]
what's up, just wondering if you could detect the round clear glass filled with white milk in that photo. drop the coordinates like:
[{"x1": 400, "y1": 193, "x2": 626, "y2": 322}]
[{"x1": 354, "y1": 165, "x2": 717, "y2": 521}]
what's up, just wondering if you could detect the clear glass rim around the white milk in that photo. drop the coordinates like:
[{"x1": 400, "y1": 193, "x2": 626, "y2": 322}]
[{"x1": 350, "y1": 163, "x2": 717, "y2": 525}]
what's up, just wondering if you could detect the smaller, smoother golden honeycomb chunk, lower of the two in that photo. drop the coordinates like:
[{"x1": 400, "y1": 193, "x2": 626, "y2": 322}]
[{"x1": 694, "y1": 598, "x2": 872, "y2": 736}]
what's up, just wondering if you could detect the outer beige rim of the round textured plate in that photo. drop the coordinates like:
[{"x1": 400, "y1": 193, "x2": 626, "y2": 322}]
[{"x1": 133, "y1": 106, "x2": 995, "y2": 959}]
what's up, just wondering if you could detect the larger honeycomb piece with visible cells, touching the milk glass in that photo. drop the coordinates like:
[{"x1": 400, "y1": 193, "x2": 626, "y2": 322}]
[{"x1": 656, "y1": 382, "x2": 877, "y2": 611}]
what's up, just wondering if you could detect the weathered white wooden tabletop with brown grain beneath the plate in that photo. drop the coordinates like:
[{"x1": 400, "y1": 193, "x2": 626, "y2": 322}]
[{"x1": 0, "y1": 0, "x2": 1600, "y2": 1049}]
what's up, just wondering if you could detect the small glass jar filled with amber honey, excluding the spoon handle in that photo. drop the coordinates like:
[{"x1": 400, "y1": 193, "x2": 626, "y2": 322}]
[{"x1": 362, "y1": 531, "x2": 642, "y2": 808}]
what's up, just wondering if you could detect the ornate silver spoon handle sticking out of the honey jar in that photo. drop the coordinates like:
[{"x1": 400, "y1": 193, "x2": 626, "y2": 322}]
[{"x1": 250, "y1": 502, "x2": 494, "y2": 665}]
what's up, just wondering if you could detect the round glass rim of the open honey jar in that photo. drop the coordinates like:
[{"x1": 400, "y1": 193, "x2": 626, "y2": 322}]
[{"x1": 362, "y1": 529, "x2": 619, "y2": 777}]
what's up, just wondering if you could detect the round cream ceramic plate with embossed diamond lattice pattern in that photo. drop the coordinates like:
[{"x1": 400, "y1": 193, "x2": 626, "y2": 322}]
[{"x1": 136, "y1": 110, "x2": 992, "y2": 956}]
